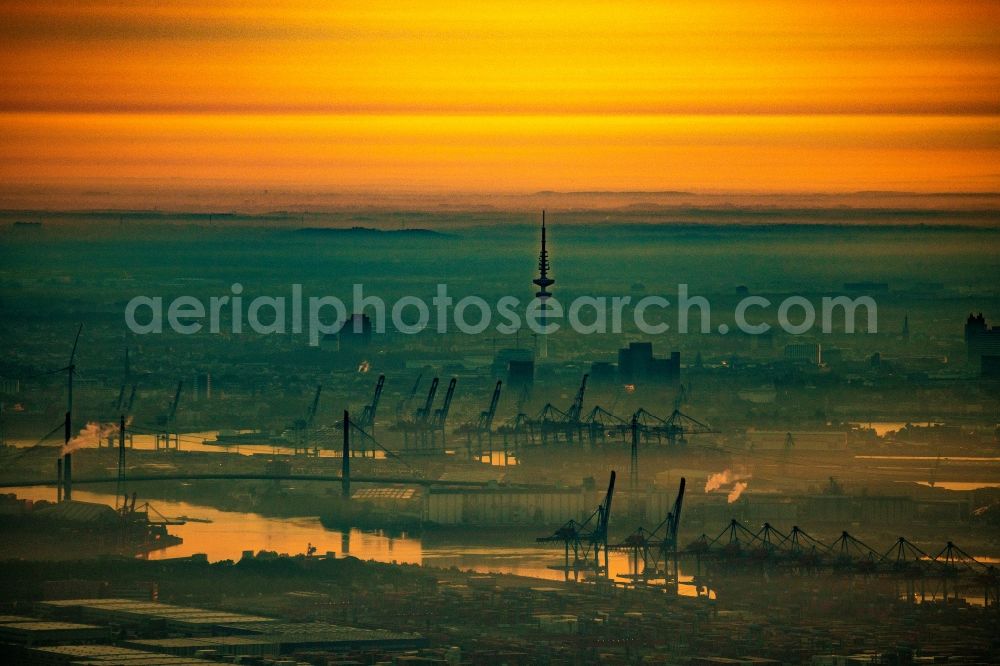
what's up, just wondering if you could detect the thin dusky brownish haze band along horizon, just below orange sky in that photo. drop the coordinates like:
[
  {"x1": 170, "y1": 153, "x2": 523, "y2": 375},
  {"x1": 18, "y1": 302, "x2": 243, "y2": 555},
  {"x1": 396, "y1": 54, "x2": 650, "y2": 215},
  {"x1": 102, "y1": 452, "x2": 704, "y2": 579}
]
[{"x1": 0, "y1": 182, "x2": 1000, "y2": 220}]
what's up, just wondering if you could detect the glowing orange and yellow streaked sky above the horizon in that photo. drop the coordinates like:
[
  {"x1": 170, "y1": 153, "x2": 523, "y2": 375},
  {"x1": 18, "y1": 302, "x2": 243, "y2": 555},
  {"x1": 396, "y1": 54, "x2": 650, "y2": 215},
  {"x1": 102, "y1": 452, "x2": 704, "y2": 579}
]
[{"x1": 0, "y1": 0, "x2": 1000, "y2": 198}]
